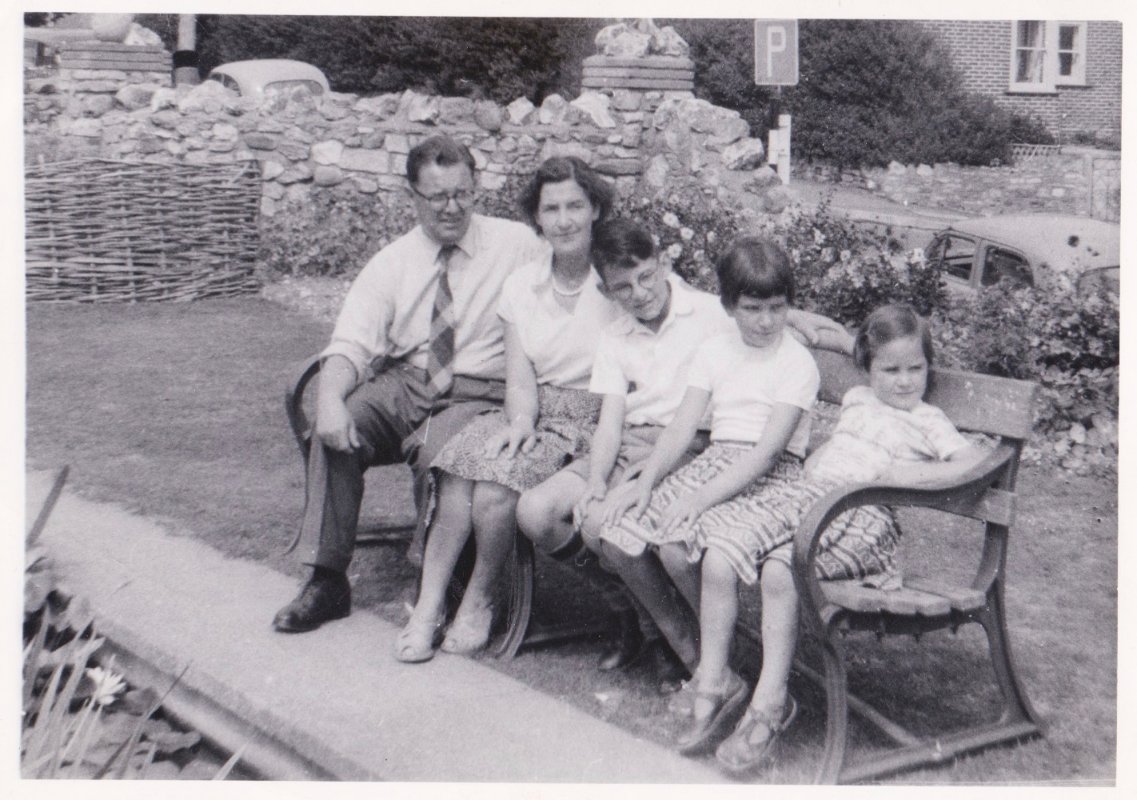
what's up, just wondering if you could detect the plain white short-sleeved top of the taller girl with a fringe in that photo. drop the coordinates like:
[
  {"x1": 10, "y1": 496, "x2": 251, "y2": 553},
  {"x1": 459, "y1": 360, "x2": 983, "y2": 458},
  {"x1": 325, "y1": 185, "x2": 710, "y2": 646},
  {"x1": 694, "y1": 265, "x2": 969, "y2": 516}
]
[{"x1": 688, "y1": 326, "x2": 821, "y2": 458}]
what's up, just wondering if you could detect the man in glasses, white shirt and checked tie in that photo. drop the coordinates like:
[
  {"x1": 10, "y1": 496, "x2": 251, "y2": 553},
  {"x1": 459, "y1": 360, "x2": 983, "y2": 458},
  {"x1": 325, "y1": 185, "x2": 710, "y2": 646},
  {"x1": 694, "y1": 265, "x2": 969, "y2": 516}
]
[{"x1": 273, "y1": 136, "x2": 547, "y2": 633}]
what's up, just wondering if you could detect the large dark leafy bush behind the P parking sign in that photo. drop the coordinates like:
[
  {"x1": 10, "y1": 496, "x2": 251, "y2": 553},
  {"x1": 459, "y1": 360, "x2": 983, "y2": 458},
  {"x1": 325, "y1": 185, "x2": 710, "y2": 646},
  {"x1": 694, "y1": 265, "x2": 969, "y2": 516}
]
[{"x1": 667, "y1": 19, "x2": 1053, "y2": 168}]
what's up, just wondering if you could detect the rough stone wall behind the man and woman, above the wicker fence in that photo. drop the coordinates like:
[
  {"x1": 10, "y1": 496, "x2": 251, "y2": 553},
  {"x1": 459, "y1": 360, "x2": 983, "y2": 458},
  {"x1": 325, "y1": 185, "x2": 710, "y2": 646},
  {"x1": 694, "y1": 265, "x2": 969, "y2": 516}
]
[{"x1": 24, "y1": 59, "x2": 764, "y2": 220}]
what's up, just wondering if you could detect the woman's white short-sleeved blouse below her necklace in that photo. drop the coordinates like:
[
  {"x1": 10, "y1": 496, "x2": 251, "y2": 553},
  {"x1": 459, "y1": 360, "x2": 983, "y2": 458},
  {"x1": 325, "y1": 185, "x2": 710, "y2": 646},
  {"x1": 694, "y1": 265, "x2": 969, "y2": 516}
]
[{"x1": 497, "y1": 253, "x2": 623, "y2": 389}]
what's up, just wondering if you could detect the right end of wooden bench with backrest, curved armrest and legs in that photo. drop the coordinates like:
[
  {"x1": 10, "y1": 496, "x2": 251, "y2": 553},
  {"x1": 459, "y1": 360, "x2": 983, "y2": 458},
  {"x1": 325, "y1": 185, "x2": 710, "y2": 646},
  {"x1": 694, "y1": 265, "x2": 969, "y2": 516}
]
[{"x1": 792, "y1": 351, "x2": 1044, "y2": 783}]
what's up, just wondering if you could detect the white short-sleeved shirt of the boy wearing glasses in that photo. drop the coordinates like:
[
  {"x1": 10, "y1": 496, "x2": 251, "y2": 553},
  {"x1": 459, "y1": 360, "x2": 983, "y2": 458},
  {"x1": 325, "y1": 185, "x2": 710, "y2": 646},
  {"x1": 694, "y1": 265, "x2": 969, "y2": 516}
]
[{"x1": 589, "y1": 275, "x2": 737, "y2": 428}]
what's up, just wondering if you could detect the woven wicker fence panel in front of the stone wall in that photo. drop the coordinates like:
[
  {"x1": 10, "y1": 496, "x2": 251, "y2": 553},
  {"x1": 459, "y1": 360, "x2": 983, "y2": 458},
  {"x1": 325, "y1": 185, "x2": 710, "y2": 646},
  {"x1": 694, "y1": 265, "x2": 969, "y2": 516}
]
[{"x1": 24, "y1": 159, "x2": 260, "y2": 302}]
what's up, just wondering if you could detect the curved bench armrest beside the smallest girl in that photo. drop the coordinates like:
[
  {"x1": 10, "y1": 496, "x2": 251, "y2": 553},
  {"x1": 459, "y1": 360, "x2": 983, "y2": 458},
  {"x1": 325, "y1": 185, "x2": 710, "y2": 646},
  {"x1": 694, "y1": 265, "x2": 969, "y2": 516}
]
[{"x1": 792, "y1": 443, "x2": 1019, "y2": 633}]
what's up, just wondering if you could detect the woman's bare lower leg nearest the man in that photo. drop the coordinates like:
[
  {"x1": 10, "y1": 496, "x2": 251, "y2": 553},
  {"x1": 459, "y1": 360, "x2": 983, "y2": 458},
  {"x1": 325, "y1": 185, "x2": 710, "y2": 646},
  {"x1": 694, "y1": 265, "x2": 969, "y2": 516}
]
[{"x1": 413, "y1": 473, "x2": 474, "y2": 622}]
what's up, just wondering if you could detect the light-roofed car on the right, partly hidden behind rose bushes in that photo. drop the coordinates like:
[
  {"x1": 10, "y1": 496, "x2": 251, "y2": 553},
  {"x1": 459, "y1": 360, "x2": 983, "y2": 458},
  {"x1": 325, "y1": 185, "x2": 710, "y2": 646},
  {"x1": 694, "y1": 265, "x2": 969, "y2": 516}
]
[{"x1": 924, "y1": 214, "x2": 1121, "y2": 291}]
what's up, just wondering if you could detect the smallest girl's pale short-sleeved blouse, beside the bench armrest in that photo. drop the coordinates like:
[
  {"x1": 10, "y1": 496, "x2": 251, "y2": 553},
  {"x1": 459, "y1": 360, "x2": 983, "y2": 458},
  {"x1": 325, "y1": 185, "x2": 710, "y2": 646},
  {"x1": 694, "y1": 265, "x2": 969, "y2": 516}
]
[{"x1": 808, "y1": 386, "x2": 969, "y2": 483}]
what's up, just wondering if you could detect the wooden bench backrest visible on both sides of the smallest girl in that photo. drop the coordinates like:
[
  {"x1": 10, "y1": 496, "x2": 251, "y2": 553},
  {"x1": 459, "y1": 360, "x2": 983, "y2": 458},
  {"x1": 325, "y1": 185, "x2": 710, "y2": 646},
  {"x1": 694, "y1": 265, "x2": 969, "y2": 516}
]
[{"x1": 812, "y1": 350, "x2": 1038, "y2": 441}]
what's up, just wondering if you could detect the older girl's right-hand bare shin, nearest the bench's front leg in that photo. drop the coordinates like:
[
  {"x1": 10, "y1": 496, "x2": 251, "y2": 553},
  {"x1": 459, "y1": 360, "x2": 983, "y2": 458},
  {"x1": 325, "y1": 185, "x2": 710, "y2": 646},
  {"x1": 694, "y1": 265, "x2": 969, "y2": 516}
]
[{"x1": 750, "y1": 558, "x2": 798, "y2": 719}]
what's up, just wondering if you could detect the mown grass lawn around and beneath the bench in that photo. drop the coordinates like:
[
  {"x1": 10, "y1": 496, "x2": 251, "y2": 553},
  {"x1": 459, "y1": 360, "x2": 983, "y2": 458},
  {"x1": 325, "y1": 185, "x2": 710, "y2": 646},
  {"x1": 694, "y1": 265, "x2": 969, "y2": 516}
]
[{"x1": 26, "y1": 299, "x2": 1118, "y2": 785}]
